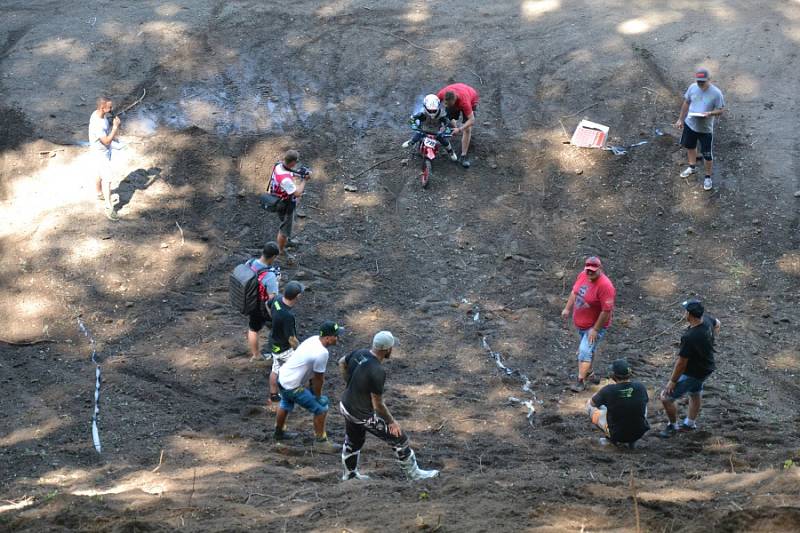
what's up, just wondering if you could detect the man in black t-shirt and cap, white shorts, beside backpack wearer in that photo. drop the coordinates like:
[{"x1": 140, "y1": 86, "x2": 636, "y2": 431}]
[{"x1": 269, "y1": 281, "x2": 303, "y2": 403}]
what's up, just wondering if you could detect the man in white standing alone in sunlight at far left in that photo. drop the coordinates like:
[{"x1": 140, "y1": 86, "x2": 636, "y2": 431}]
[{"x1": 89, "y1": 96, "x2": 122, "y2": 221}]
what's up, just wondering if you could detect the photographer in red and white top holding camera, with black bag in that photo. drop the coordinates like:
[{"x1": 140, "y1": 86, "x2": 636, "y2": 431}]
[{"x1": 269, "y1": 150, "x2": 311, "y2": 254}]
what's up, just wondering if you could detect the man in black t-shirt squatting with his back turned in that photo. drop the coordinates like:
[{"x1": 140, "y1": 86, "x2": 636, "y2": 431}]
[{"x1": 586, "y1": 359, "x2": 650, "y2": 448}]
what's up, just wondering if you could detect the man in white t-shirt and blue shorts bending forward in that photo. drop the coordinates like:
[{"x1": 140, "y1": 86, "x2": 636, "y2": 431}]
[{"x1": 274, "y1": 320, "x2": 342, "y2": 453}]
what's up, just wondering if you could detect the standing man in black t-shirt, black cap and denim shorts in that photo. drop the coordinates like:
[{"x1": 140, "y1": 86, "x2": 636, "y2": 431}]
[{"x1": 658, "y1": 299, "x2": 721, "y2": 439}]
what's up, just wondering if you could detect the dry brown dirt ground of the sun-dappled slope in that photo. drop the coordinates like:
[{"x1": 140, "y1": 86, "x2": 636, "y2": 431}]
[{"x1": 0, "y1": 0, "x2": 800, "y2": 532}]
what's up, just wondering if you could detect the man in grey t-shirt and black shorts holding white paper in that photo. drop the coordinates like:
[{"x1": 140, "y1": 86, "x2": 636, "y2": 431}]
[{"x1": 675, "y1": 68, "x2": 725, "y2": 191}]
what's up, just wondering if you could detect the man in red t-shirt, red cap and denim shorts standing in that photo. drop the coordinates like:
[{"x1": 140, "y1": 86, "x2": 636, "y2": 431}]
[{"x1": 561, "y1": 256, "x2": 617, "y2": 392}]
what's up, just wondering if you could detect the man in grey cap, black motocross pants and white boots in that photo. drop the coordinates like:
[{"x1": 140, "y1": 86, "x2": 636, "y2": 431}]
[{"x1": 339, "y1": 331, "x2": 439, "y2": 481}]
